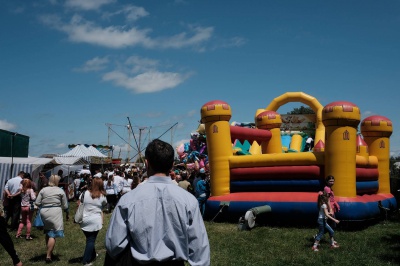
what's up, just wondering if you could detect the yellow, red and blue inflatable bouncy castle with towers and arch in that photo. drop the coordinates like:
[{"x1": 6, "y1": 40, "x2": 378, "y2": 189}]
[{"x1": 201, "y1": 92, "x2": 397, "y2": 221}]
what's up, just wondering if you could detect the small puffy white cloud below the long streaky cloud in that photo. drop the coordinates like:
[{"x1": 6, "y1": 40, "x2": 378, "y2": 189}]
[{"x1": 103, "y1": 70, "x2": 187, "y2": 93}]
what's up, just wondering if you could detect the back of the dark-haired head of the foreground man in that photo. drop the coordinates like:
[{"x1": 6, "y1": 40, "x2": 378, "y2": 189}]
[{"x1": 145, "y1": 139, "x2": 174, "y2": 175}]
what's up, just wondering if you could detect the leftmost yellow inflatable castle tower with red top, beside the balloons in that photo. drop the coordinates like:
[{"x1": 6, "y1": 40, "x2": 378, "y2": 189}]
[{"x1": 201, "y1": 101, "x2": 233, "y2": 196}]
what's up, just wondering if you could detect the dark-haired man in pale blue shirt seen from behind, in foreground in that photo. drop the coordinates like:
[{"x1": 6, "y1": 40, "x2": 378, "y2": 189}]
[{"x1": 105, "y1": 139, "x2": 210, "y2": 266}]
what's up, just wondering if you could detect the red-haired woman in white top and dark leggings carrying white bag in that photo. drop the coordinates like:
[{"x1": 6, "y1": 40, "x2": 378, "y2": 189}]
[{"x1": 78, "y1": 178, "x2": 107, "y2": 265}]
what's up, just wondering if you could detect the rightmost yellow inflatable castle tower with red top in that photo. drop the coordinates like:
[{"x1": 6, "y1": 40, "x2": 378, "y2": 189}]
[{"x1": 361, "y1": 115, "x2": 393, "y2": 193}]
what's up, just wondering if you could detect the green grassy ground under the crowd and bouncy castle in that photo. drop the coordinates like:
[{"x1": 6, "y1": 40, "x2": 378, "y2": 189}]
[{"x1": 0, "y1": 202, "x2": 400, "y2": 266}]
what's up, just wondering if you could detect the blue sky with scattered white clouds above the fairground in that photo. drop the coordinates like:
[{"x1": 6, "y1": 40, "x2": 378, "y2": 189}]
[{"x1": 0, "y1": 0, "x2": 400, "y2": 160}]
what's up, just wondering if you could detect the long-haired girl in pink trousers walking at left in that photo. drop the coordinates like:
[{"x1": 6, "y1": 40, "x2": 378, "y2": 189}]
[{"x1": 15, "y1": 179, "x2": 36, "y2": 240}]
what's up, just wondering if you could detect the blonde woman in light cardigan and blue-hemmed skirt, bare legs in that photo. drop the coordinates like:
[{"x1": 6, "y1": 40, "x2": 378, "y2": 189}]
[{"x1": 35, "y1": 175, "x2": 68, "y2": 263}]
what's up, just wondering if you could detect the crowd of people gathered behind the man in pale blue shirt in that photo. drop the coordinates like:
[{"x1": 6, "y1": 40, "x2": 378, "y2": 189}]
[{"x1": 0, "y1": 140, "x2": 210, "y2": 266}]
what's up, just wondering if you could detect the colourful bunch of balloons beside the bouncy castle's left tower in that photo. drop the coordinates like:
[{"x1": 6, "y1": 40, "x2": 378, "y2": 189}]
[{"x1": 176, "y1": 132, "x2": 208, "y2": 170}]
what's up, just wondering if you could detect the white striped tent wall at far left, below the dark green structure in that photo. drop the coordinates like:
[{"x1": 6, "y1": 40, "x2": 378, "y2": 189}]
[{"x1": 0, "y1": 157, "x2": 54, "y2": 195}]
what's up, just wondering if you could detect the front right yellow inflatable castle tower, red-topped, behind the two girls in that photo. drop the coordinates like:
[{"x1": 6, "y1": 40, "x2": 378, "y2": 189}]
[{"x1": 322, "y1": 101, "x2": 361, "y2": 197}]
